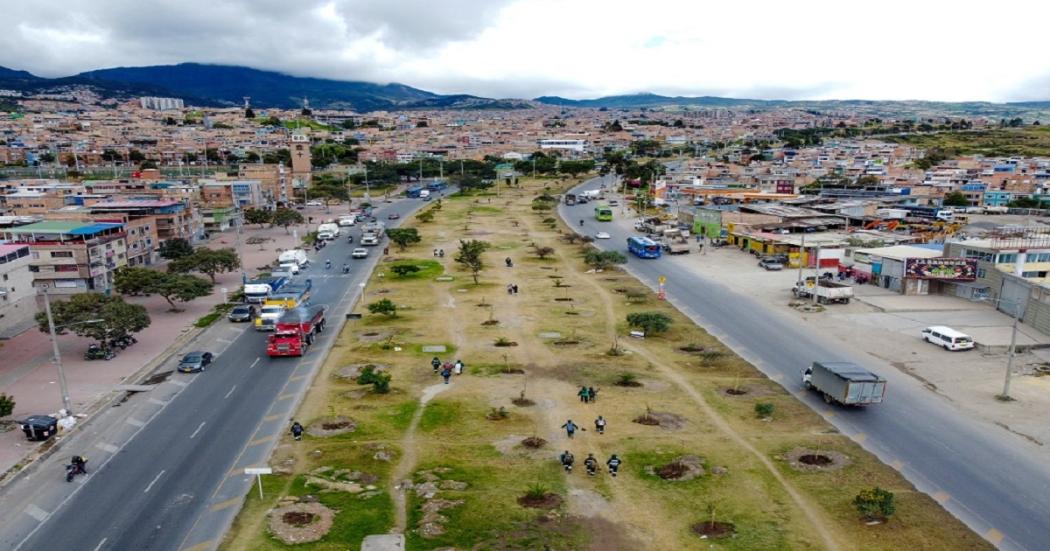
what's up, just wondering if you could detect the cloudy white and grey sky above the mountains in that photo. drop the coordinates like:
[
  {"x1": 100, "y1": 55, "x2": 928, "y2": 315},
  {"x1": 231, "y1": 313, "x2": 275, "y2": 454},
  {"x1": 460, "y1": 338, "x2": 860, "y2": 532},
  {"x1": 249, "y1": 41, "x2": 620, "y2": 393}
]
[{"x1": 0, "y1": 0, "x2": 1050, "y2": 101}]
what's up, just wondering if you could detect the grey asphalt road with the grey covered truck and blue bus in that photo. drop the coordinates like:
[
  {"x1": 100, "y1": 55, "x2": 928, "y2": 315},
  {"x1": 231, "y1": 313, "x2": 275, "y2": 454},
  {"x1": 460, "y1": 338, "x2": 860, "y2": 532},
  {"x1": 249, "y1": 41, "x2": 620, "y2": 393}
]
[{"x1": 559, "y1": 178, "x2": 1050, "y2": 551}]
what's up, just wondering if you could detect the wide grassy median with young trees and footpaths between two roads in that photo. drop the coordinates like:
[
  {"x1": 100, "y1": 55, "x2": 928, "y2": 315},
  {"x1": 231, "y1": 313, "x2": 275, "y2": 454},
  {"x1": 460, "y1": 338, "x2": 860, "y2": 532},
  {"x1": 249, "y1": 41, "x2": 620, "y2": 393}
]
[{"x1": 224, "y1": 178, "x2": 991, "y2": 551}]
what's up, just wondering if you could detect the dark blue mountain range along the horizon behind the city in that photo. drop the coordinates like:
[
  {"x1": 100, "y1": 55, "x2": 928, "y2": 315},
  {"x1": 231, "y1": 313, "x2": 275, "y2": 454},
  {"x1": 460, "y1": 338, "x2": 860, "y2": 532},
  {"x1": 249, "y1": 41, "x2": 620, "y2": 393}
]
[{"x1": 0, "y1": 63, "x2": 1050, "y2": 118}]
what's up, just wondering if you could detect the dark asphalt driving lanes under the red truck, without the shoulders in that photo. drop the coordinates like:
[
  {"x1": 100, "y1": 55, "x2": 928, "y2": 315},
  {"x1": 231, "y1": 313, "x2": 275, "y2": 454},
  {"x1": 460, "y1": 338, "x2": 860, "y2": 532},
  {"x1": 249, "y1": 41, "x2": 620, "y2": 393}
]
[{"x1": 7, "y1": 195, "x2": 419, "y2": 551}]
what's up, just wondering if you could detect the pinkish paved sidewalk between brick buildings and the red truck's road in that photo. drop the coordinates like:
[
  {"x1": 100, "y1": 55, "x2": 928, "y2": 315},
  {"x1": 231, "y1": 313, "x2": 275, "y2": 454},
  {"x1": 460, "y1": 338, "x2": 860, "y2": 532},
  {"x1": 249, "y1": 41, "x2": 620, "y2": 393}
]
[{"x1": 0, "y1": 217, "x2": 310, "y2": 473}]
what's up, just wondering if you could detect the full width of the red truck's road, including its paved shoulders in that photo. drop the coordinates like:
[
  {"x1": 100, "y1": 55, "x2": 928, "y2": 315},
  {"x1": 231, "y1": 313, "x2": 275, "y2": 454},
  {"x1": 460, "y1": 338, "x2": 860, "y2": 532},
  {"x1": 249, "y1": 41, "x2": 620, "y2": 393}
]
[{"x1": 0, "y1": 195, "x2": 420, "y2": 551}]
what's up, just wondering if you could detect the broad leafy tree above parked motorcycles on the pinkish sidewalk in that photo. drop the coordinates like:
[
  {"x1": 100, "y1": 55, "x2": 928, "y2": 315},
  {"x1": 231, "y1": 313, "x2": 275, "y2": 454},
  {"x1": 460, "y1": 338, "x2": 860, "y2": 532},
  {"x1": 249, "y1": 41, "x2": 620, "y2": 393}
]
[{"x1": 36, "y1": 289, "x2": 151, "y2": 345}]
